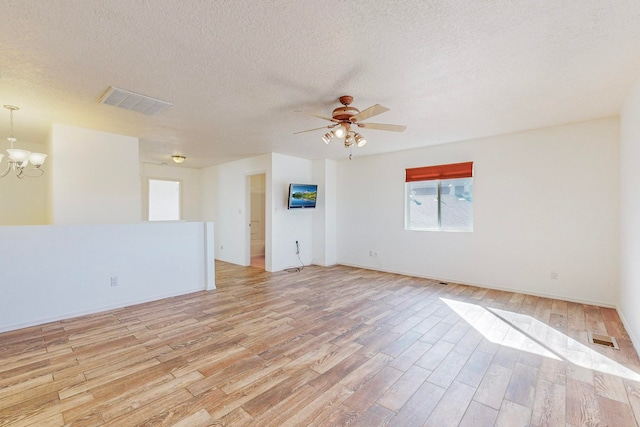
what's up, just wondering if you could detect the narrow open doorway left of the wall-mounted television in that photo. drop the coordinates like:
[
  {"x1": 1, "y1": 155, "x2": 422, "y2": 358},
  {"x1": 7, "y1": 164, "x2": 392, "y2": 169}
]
[{"x1": 249, "y1": 173, "x2": 267, "y2": 270}]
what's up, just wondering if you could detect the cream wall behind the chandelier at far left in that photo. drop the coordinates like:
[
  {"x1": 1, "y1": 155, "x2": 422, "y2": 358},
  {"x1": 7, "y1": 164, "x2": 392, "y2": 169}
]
[{"x1": 0, "y1": 139, "x2": 51, "y2": 226}]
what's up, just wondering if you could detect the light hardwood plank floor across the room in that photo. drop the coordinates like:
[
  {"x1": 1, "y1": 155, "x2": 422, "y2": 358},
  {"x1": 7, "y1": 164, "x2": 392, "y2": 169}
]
[{"x1": 0, "y1": 262, "x2": 640, "y2": 427}]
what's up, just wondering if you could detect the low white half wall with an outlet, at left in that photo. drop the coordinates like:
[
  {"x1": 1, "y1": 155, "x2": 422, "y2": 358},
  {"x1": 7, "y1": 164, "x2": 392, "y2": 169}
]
[{"x1": 0, "y1": 222, "x2": 215, "y2": 332}]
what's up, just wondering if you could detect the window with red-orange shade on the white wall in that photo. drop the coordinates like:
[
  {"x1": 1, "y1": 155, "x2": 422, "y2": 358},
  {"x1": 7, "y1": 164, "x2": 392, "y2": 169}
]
[{"x1": 405, "y1": 162, "x2": 473, "y2": 231}]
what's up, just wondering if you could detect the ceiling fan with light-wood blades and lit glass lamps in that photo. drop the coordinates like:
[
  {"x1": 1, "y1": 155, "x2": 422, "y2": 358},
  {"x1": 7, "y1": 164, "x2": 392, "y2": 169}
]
[{"x1": 294, "y1": 95, "x2": 407, "y2": 157}]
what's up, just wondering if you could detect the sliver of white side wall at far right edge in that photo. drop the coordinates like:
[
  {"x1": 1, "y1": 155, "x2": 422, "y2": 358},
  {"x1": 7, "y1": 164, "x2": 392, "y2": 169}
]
[{"x1": 618, "y1": 79, "x2": 640, "y2": 352}]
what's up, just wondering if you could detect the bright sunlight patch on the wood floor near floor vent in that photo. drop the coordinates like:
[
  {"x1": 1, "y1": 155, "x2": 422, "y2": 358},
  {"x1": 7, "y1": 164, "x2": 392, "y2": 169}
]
[{"x1": 440, "y1": 298, "x2": 640, "y2": 381}]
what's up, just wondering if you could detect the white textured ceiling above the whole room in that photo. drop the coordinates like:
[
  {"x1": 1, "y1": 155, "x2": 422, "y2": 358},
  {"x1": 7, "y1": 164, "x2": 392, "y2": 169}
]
[{"x1": 0, "y1": 0, "x2": 640, "y2": 167}]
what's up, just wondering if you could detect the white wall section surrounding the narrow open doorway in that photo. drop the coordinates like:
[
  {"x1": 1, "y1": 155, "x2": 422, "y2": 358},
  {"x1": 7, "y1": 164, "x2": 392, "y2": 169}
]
[{"x1": 202, "y1": 154, "x2": 271, "y2": 267}]
